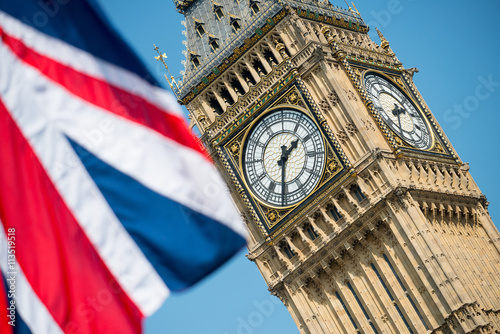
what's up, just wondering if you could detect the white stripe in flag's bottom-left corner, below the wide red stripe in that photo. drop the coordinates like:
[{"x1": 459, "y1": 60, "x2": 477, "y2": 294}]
[{"x1": 0, "y1": 222, "x2": 63, "y2": 334}]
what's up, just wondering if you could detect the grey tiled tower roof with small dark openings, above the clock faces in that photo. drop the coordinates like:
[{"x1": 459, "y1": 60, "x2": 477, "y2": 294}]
[{"x1": 174, "y1": 0, "x2": 366, "y2": 100}]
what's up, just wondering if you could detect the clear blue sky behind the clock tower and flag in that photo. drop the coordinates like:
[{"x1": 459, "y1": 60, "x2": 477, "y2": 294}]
[{"x1": 100, "y1": 0, "x2": 500, "y2": 334}]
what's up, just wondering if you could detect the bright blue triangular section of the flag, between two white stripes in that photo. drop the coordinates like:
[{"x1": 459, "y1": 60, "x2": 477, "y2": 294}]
[{"x1": 69, "y1": 139, "x2": 246, "y2": 291}]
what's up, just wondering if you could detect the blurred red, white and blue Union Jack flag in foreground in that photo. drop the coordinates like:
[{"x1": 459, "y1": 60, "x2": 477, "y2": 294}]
[{"x1": 0, "y1": 0, "x2": 246, "y2": 334}]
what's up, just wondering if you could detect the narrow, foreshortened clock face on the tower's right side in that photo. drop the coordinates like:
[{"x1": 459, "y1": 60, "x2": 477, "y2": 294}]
[{"x1": 365, "y1": 74, "x2": 432, "y2": 150}]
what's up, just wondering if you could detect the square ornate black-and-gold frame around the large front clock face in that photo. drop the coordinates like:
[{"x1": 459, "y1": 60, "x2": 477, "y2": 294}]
[{"x1": 217, "y1": 80, "x2": 354, "y2": 240}]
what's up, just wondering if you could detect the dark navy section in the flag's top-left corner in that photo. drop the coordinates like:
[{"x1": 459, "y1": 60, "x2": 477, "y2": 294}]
[{"x1": 0, "y1": 0, "x2": 160, "y2": 86}]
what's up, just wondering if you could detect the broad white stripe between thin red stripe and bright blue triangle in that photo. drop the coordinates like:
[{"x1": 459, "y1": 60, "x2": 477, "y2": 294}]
[{"x1": 0, "y1": 34, "x2": 247, "y2": 238}]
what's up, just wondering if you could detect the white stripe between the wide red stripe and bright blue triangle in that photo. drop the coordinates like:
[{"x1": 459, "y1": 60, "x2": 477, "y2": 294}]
[{"x1": 0, "y1": 44, "x2": 169, "y2": 316}]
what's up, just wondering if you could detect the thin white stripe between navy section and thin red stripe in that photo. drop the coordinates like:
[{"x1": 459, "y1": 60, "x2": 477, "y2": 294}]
[{"x1": 0, "y1": 11, "x2": 182, "y2": 117}]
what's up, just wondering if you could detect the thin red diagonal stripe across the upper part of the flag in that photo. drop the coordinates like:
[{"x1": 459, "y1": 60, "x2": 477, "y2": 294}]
[{"x1": 0, "y1": 27, "x2": 207, "y2": 160}]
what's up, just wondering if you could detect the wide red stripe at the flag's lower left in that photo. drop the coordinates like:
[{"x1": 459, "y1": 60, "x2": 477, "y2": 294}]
[{"x1": 0, "y1": 100, "x2": 142, "y2": 334}]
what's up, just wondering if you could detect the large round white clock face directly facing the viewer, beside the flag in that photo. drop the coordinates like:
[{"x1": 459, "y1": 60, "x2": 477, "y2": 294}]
[{"x1": 242, "y1": 108, "x2": 325, "y2": 207}]
